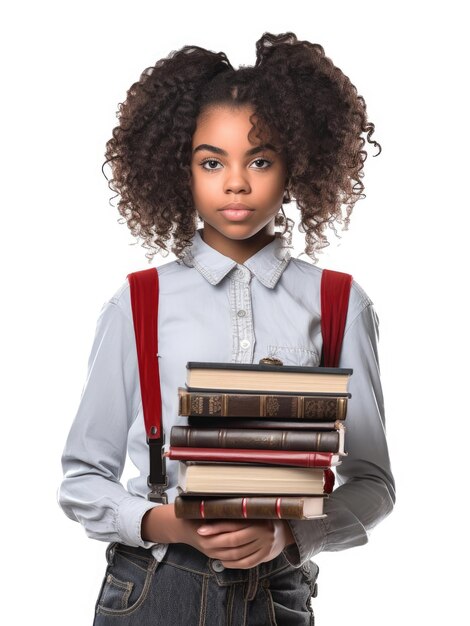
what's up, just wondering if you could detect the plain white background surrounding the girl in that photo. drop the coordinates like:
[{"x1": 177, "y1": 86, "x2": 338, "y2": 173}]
[{"x1": 0, "y1": 0, "x2": 469, "y2": 626}]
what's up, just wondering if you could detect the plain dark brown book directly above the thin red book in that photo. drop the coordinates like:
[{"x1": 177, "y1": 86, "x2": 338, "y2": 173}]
[{"x1": 170, "y1": 426, "x2": 340, "y2": 452}]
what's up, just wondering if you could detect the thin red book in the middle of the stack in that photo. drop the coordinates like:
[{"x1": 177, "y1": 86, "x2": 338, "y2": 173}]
[{"x1": 165, "y1": 447, "x2": 337, "y2": 467}]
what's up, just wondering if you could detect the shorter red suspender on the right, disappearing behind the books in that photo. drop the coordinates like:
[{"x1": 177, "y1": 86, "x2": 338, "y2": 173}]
[{"x1": 321, "y1": 270, "x2": 352, "y2": 367}]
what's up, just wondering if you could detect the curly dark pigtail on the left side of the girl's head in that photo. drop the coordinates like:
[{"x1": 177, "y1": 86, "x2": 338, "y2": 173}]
[{"x1": 104, "y1": 46, "x2": 233, "y2": 261}]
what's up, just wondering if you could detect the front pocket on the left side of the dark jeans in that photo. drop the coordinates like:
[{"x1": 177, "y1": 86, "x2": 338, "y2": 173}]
[{"x1": 96, "y1": 543, "x2": 157, "y2": 616}]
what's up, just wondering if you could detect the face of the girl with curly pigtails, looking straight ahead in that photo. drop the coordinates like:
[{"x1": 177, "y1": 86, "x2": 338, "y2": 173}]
[{"x1": 191, "y1": 105, "x2": 287, "y2": 256}]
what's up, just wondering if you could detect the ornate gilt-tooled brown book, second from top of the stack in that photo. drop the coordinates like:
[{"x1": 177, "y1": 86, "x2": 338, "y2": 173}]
[{"x1": 178, "y1": 387, "x2": 350, "y2": 421}]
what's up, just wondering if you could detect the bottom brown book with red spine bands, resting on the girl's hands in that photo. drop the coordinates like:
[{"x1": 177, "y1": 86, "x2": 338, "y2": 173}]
[{"x1": 175, "y1": 496, "x2": 327, "y2": 519}]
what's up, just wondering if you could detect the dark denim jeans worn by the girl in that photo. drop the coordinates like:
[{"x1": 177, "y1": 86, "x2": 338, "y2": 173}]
[{"x1": 93, "y1": 543, "x2": 318, "y2": 626}]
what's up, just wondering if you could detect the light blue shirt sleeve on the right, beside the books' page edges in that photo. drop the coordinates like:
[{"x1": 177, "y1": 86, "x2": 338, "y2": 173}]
[{"x1": 285, "y1": 292, "x2": 395, "y2": 567}]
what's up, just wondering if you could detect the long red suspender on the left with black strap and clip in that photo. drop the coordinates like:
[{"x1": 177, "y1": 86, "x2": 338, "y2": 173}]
[{"x1": 127, "y1": 268, "x2": 168, "y2": 503}]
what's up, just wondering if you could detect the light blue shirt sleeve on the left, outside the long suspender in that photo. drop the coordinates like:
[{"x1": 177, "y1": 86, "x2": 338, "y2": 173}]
[{"x1": 58, "y1": 292, "x2": 158, "y2": 548}]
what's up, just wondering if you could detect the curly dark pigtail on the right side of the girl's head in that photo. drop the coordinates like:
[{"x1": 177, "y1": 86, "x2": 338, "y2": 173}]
[{"x1": 255, "y1": 32, "x2": 381, "y2": 254}]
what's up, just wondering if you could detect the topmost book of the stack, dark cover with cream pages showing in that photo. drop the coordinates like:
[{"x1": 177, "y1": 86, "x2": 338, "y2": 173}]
[{"x1": 186, "y1": 361, "x2": 352, "y2": 394}]
